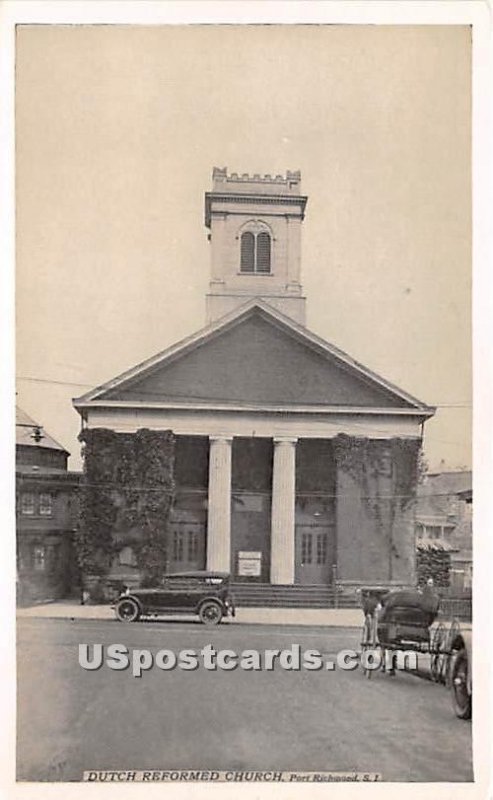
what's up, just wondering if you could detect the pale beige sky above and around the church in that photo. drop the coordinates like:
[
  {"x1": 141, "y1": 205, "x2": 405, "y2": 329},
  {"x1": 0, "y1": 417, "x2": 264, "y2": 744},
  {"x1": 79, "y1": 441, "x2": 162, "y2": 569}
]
[{"x1": 16, "y1": 25, "x2": 472, "y2": 470}]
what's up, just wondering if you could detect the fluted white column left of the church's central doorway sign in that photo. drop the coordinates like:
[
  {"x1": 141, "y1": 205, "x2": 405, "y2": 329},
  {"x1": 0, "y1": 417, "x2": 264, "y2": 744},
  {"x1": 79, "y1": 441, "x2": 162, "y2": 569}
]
[{"x1": 207, "y1": 436, "x2": 233, "y2": 572}]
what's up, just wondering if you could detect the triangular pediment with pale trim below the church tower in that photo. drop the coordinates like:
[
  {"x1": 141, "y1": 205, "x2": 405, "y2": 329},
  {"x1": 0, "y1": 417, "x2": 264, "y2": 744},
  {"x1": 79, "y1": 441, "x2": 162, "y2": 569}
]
[{"x1": 75, "y1": 301, "x2": 429, "y2": 413}]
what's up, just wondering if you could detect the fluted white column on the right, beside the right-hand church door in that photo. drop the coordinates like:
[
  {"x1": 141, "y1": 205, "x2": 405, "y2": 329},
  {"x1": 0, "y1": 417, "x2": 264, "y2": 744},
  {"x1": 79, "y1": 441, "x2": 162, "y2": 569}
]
[{"x1": 270, "y1": 437, "x2": 296, "y2": 584}]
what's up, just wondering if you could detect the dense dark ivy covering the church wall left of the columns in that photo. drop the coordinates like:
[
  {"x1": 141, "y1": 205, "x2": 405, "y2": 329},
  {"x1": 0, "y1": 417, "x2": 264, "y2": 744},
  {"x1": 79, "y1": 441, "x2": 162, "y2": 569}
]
[{"x1": 76, "y1": 428, "x2": 175, "y2": 585}]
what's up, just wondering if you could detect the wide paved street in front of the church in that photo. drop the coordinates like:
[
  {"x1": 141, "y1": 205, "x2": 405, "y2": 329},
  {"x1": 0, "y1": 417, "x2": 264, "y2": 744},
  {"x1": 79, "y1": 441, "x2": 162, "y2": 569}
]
[{"x1": 18, "y1": 618, "x2": 472, "y2": 781}]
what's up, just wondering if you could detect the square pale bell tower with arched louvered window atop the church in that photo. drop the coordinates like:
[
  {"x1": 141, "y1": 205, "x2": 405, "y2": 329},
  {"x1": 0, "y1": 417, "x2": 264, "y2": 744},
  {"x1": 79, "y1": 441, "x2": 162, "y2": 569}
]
[{"x1": 205, "y1": 167, "x2": 307, "y2": 325}]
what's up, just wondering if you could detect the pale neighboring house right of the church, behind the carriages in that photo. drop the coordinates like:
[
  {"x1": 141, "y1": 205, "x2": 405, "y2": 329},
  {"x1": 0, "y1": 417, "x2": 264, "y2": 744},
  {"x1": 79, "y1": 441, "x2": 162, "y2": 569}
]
[{"x1": 416, "y1": 471, "x2": 472, "y2": 592}]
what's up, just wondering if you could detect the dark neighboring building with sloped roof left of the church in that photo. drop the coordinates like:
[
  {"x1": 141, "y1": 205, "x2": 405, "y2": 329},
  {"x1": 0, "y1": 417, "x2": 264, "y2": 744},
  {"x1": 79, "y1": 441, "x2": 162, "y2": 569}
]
[{"x1": 16, "y1": 409, "x2": 80, "y2": 604}]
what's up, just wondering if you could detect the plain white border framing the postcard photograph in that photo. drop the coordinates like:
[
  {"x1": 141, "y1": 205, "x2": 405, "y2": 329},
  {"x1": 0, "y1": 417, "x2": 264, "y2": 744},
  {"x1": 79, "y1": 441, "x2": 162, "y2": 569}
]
[{"x1": 0, "y1": 0, "x2": 493, "y2": 800}]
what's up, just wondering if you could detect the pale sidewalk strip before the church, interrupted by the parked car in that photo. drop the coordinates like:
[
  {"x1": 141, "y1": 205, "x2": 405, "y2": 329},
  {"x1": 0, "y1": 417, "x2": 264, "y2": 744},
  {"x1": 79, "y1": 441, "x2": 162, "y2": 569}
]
[{"x1": 17, "y1": 601, "x2": 363, "y2": 628}]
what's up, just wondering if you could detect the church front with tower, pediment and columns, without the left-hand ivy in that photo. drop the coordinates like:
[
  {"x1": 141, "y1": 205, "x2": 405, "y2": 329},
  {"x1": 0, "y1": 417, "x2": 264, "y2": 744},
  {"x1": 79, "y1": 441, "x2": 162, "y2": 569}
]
[{"x1": 74, "y1": 168, "x2": 434, "y2": 594}]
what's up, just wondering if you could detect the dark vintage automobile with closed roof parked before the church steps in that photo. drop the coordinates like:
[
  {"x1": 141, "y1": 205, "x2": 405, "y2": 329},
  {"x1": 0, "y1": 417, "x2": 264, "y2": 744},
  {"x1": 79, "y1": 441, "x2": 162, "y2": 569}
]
[{"x1": 114, "y1": 570, "x2": 235, "y2": 625}]
